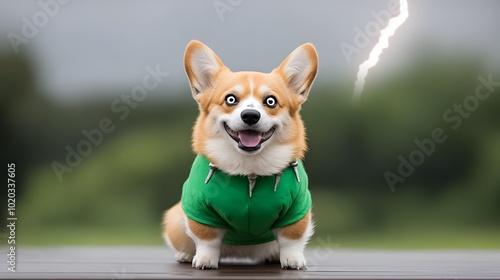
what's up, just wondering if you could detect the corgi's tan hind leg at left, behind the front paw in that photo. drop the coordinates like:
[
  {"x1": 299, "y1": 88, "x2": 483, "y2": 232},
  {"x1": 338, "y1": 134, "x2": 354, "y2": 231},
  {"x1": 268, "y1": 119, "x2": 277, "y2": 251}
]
[{"x1": 163, "y1": 202, "x2": 196, "y2": 263}]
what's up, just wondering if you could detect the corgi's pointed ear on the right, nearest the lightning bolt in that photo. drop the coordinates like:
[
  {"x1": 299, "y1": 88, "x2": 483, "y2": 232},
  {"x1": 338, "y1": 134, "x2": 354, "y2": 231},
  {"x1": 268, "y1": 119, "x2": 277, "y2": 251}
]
[{"x1": 273, "y1": 43, "x2": 318, "y2": 102}]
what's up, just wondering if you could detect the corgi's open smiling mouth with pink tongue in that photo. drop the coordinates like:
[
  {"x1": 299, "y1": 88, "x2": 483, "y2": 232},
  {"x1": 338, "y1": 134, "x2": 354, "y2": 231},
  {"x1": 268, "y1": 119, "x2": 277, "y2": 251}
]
[{"x1": 224, "y1": 123, "x2": 275, "y2": 152}]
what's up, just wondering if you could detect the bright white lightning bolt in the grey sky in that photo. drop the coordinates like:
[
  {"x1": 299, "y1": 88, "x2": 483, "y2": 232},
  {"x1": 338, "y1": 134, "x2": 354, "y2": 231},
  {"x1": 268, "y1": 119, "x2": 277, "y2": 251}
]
[{"x1": 353, "y1": 0, "x2": 408, "y2": 100}]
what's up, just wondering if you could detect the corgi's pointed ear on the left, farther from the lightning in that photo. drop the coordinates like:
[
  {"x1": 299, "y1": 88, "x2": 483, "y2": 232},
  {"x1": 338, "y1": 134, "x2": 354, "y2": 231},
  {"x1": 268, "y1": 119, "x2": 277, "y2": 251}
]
[{"x1": 184, "y1": 40, "x2": 225, "y2": 100}]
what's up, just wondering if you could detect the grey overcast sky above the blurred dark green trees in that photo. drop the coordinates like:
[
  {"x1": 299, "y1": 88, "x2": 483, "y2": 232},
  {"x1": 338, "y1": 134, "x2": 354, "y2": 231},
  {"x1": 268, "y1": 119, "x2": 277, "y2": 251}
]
[{"x1": 0, "y1": 0, "x2": 500, "y2": 101}]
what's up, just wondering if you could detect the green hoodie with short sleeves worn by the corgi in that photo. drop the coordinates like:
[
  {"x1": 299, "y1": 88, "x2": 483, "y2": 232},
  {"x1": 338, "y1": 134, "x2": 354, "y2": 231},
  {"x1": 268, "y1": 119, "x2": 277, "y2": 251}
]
[{"x1": 181, "y1": 155, "x2": 311, "y2": 245}]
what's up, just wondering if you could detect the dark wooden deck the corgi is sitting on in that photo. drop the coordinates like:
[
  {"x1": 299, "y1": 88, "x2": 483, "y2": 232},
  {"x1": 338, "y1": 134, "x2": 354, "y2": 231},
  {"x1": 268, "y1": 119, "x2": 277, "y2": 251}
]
[{"x1": 0, "y1": 247, "x2": 500, "y2": 279}]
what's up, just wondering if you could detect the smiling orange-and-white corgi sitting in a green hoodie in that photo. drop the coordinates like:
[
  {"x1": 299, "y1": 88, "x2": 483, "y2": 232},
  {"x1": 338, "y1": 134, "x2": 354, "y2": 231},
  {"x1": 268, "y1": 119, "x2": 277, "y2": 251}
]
[{"x1": 163, "y1": 41, "x2": 318, "y2": 269}]
